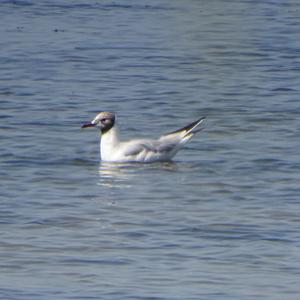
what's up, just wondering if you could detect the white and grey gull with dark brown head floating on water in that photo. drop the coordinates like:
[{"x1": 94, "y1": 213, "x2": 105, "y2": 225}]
[{"x1": 81, "y1": 111, "x2": 205, "y2": 163}]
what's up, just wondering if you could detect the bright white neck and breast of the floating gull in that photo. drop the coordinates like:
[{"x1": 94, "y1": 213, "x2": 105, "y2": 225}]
[{"x1": 100, "y1": 125, "x2": 120, "y2": 161}]
